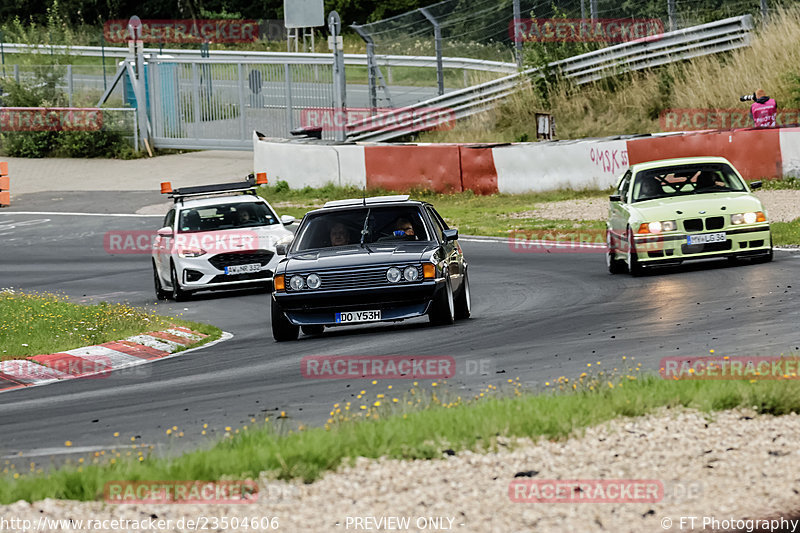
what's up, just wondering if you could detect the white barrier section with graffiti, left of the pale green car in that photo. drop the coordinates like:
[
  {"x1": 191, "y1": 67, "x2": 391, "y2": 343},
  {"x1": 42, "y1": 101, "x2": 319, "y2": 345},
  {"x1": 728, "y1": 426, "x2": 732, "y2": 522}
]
[{"x1": 492, "y1": 140, "x2": 628, "y2": 193}]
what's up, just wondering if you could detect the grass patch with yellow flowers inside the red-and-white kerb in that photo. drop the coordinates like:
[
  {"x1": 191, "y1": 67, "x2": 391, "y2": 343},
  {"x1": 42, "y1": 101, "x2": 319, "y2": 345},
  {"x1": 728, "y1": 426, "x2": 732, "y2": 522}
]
[{"x1": 0, "y1": 289, "x2": 222, "y2": 360}]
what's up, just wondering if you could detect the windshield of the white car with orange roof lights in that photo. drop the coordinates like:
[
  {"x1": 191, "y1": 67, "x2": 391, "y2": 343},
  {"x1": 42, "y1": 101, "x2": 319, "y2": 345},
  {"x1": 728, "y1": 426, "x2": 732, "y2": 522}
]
[{"x1": 178, "y1": 202, "x2": 280, "y2": 233}]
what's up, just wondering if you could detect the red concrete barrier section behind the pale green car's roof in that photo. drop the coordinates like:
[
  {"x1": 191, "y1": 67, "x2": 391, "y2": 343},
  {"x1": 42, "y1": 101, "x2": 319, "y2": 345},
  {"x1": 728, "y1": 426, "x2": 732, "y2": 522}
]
[{"x1": 628, "y1": 129, "x2": 783, "y2": 180}]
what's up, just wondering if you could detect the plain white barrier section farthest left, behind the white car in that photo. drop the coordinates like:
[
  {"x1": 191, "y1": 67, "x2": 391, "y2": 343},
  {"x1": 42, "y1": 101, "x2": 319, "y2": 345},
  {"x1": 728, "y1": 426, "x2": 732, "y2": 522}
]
[{"x1": 253, "y1": 134, "x2": 367, "y2": 189}]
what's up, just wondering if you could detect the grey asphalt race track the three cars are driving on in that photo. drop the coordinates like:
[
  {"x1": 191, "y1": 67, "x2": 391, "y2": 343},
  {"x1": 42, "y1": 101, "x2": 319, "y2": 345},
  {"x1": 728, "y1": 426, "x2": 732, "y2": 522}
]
[{"x1": 0, "y1": 192, "x2": 800, "y2": 463}]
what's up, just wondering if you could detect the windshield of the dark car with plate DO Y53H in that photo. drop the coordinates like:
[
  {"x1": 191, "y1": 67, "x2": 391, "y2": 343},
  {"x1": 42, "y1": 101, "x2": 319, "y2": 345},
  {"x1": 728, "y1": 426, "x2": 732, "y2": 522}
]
[{"x1": 292, "y1": 206, "x2": 432, "y2": 252}]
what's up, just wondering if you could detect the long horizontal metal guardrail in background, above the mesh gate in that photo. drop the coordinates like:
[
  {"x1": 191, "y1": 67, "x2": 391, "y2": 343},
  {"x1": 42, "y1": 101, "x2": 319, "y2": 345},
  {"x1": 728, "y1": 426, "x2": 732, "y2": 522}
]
[{"x1": 3, "y1": 43, "x2": 517, "y2": 74}]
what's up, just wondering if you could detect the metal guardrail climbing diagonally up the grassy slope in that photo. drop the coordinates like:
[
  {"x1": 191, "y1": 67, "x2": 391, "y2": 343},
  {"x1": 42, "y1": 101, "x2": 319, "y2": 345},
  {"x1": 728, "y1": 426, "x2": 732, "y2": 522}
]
[{"x1": 347, "y1": 15, "x2": 753, "y2": 142}]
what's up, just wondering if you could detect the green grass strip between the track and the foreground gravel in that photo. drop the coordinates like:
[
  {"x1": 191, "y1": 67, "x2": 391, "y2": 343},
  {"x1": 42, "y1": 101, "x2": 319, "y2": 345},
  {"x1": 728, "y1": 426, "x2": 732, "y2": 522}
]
[{"x1": 0, "y1": 373, "x2": 800, "y2": 504}]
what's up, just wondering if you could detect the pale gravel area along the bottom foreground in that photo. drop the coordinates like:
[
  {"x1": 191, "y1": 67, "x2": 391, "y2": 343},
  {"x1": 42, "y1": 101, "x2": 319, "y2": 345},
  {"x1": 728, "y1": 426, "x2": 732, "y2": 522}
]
[{"x1": 0, "y1": 408, "x2": 800, "y2": 533}]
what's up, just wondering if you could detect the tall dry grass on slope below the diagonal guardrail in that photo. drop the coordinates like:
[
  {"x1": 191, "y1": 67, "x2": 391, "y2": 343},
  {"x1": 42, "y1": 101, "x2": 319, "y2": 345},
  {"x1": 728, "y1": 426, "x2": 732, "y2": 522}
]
[{"x1": 420, "y1": 7, "x2": 800, "y2": 142}]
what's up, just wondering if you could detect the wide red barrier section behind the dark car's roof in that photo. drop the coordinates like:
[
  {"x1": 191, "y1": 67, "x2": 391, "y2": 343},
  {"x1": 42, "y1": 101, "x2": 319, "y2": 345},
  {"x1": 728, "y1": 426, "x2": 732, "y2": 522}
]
[{"x1": 364, "y1": 145, "x2": 462, "y2": 193}]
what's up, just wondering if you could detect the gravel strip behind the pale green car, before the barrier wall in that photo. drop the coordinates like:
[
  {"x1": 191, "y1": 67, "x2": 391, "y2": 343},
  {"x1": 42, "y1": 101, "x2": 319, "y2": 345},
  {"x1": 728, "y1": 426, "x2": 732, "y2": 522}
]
[{"x1": 511, "y1": 189, "x2": 800, "y2": 222}]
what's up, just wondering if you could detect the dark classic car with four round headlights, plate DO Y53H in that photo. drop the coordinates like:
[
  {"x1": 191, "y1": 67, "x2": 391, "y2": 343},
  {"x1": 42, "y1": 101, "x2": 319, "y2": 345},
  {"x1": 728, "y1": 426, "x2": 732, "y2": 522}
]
[{"x1": 272, "y1": 196, "x2": 470, "y2": 341}]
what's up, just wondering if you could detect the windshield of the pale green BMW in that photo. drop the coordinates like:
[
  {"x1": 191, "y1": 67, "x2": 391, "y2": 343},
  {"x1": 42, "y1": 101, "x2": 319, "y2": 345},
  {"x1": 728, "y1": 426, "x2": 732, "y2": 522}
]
[{"x1": 633, "y1": 163, "x2": 746, "y2": 202}]
